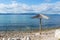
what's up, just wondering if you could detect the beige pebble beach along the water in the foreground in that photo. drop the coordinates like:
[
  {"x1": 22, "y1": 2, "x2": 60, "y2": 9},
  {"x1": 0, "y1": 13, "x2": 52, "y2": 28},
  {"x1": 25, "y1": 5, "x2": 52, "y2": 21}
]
[{"x1": 0, "y1": 30, "x2": 58, "y2": 40}]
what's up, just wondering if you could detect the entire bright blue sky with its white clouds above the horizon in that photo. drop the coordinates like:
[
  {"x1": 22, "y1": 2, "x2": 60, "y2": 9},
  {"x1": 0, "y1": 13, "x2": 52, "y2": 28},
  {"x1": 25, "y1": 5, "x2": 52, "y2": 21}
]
[{"x1": 0, "y1": 0, "x2": 60, "y2": 14}]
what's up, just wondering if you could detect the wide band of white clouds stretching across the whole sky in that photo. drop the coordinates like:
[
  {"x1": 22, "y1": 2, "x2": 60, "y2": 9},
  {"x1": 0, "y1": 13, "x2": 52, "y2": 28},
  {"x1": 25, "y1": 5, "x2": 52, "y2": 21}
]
[{"x1": 0, "y1": 1, "x2": 60, "y2": 14}]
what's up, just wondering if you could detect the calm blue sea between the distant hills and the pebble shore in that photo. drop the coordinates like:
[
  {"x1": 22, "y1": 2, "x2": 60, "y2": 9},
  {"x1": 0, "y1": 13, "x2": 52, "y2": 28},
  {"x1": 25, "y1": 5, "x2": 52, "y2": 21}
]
[{"x1": 0, "y1": 13, "x2": 60, "y2": 31}]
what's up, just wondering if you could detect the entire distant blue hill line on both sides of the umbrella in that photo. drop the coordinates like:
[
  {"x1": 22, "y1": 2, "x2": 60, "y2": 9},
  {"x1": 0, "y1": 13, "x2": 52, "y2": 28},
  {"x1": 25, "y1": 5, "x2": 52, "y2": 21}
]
[{"x1": 0, "y1": 13, "x2": 60, "y2": 16}]
